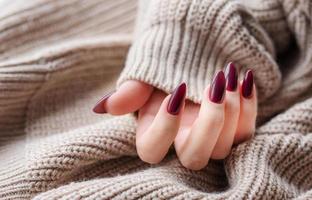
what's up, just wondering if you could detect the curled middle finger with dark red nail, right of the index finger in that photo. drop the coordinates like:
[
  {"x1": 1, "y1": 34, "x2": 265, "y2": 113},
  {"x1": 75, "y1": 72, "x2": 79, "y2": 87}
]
[{"x1": 175, "y1": 71, "x2": 225, "y2": 170}]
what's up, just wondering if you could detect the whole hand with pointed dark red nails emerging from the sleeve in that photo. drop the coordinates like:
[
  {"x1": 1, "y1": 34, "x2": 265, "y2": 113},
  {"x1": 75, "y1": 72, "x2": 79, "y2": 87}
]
[{"x1": 94, "y1": 63, "x2": 257, "y2": 170}]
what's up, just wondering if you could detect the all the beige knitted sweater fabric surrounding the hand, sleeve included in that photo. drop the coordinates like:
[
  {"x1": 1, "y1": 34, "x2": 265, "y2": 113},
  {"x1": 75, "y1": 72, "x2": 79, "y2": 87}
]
[{"x1": 0, "y1": 0, "x2": 312, "y2": 200}]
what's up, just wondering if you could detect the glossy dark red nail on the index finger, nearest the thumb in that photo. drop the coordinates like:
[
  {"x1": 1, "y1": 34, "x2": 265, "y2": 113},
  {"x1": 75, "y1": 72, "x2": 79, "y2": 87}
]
[{"x1": 167, "y1": 83, "x2": 186, "y2": 115}]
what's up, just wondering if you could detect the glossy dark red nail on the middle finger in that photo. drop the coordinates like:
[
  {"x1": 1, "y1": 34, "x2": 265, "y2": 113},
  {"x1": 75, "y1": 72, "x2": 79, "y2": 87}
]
[{"x1": 209, "y1": 71, "x2": 225, "y2": 103}]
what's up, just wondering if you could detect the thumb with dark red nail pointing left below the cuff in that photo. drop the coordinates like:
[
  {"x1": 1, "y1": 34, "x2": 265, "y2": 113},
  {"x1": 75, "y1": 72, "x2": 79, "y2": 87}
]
[{"x1": 93, "y1": 80, "x2": 153, "y2": 115}]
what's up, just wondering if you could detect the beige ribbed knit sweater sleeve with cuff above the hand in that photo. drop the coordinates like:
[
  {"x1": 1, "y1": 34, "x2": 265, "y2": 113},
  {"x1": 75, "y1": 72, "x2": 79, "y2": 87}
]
[{"x1": 117, "y1": 0, "x2": 281, "y2": 103}]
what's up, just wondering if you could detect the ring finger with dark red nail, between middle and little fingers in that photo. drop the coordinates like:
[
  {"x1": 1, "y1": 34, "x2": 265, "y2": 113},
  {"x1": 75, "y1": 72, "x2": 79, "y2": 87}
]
[{"x1": 211, "y1": 63, "x2": 240, "y2": 159}]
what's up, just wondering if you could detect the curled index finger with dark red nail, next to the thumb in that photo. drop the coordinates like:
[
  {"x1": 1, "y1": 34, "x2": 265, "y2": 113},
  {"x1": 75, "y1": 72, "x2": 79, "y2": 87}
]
[{"x1": 136, "y1": 83, "x2": 186, "y2": 164}]
